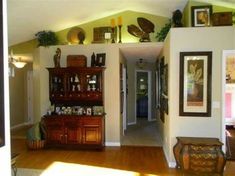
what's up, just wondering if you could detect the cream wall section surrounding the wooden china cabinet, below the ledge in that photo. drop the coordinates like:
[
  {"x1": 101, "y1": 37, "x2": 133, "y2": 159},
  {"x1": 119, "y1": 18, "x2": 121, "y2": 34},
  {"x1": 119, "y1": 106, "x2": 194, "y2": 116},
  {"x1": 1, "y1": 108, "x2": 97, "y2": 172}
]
[{"x1": 34, "y1": 44, "x2": 120, "y2": 145}]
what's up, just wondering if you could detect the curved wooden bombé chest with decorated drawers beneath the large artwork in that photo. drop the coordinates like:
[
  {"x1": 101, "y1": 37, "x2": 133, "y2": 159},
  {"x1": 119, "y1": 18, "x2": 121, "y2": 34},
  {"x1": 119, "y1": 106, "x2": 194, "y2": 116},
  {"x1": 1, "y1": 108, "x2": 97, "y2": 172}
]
[{"x1": 173, "y1": 137, "x2": 226, "y2": 175}]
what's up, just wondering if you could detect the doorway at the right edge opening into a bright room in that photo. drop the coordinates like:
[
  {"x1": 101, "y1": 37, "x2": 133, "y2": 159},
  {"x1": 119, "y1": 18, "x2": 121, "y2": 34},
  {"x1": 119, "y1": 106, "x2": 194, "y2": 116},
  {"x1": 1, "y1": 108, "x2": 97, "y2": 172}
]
[{"x1": 222, "y1": 50, "x2": 235, "y2": 160}]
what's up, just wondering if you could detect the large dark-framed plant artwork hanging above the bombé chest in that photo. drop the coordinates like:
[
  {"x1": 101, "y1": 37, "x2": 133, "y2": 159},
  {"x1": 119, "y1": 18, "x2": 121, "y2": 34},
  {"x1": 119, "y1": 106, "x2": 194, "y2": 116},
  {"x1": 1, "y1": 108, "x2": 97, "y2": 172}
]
[{"x1": 179, "y1": 51, "x2": 212, "y2": 117}]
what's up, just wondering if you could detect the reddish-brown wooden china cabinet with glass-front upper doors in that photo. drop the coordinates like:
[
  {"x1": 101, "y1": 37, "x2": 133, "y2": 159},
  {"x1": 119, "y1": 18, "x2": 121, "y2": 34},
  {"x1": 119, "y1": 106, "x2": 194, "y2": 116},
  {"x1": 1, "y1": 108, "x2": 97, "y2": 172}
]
[{"x1": 43, "y1": 67, "x2": 105, "y2": 148}]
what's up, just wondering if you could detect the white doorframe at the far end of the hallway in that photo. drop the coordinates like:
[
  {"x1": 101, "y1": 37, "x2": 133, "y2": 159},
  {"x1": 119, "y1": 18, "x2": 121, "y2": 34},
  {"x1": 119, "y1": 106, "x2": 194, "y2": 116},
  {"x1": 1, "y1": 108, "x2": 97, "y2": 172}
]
[{"x1": 135, "y1": 70, "x2": 153, "y2": 123}]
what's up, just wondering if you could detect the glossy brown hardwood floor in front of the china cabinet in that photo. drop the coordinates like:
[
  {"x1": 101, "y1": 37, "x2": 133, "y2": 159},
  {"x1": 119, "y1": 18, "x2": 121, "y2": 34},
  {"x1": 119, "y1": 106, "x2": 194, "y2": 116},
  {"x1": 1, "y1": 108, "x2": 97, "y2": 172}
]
[{"x1": 12, "y1": 139, "x2": 235, "y2": 176}]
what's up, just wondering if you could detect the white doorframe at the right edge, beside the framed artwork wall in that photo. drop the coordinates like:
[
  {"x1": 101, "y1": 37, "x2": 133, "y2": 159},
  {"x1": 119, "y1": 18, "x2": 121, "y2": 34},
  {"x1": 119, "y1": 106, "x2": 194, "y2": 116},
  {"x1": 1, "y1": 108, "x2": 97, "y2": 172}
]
[{"x1": 221, "y1": 50, "x2": 235, "y2": 152}]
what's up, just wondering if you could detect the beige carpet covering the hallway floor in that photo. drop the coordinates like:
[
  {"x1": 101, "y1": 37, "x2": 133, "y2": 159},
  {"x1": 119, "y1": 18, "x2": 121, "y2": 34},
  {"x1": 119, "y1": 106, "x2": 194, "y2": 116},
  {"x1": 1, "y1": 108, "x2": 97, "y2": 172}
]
[{"x1": 121, "y1": 118, "x2": 162, "y2": 146}]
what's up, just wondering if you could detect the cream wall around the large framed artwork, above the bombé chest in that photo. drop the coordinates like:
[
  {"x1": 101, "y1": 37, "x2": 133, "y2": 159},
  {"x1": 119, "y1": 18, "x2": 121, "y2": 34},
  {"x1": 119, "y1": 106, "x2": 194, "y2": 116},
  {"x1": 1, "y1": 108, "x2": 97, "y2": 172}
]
[{"x1": 164, "y1": 27, "x2": 235, "y2": 165}]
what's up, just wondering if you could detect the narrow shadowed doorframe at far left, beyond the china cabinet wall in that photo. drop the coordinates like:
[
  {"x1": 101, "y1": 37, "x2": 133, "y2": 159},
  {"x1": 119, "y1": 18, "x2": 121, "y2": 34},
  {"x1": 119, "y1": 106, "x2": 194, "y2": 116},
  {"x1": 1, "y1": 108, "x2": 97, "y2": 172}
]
[{"x1": 26, "y1": 71, "x2": 34, "y2": 124}]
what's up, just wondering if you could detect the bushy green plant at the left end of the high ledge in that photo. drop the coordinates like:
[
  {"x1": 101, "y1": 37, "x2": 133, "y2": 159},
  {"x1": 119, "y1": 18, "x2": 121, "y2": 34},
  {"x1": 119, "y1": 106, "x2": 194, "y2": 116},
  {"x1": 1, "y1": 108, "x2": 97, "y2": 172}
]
[{"x1": 35, "y1": 30, "x2": 58, "y2": 47}]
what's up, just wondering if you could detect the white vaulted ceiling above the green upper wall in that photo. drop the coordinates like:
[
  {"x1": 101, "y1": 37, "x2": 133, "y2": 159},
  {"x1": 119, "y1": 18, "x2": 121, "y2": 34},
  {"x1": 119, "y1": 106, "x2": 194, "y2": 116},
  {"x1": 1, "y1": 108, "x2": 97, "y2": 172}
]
[{"x1": 7, "y1": 0, "x2": 235, "y2": 46}]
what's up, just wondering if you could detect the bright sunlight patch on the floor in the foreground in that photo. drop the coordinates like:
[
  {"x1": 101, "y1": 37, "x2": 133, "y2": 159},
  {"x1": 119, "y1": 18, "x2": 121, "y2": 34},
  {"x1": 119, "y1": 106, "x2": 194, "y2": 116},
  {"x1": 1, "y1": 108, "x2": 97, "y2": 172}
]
[{"x1": 40, "y1": 162, "x2": 157, "y2": 176}]
